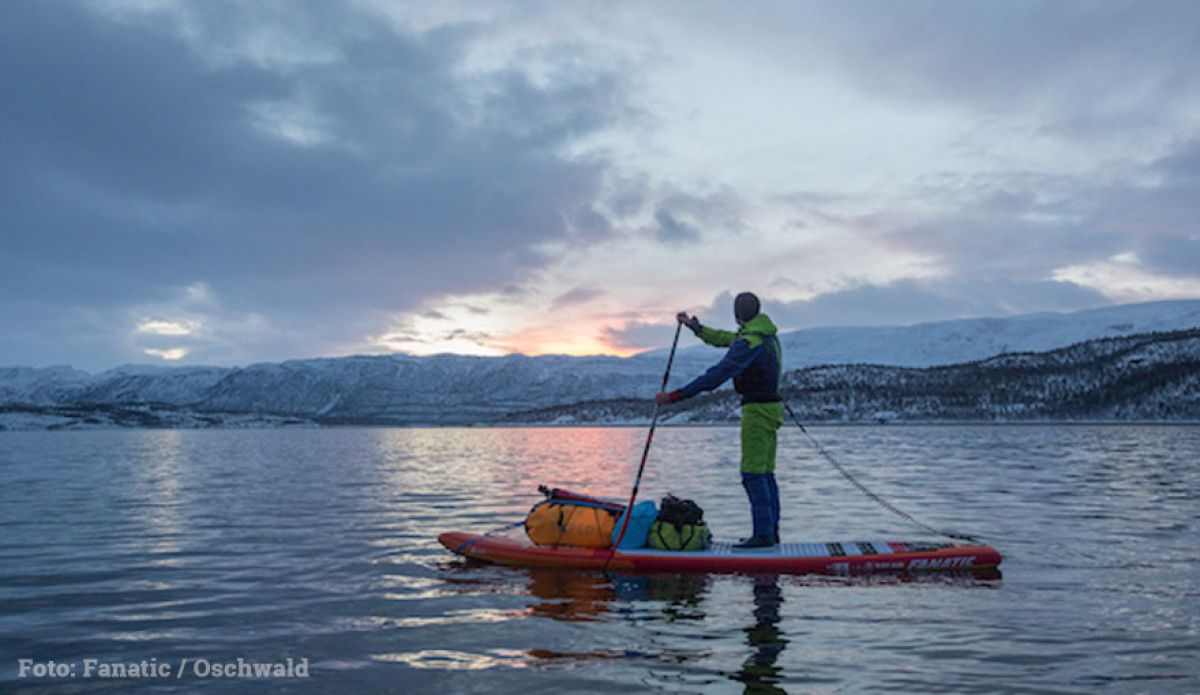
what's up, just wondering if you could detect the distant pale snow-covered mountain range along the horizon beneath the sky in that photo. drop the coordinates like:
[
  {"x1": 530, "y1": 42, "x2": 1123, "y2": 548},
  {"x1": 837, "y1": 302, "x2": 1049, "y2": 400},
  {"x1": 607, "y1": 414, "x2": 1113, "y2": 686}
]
[{"x1": 0, "y1": 301, "x2": 1200, "y2": 424}]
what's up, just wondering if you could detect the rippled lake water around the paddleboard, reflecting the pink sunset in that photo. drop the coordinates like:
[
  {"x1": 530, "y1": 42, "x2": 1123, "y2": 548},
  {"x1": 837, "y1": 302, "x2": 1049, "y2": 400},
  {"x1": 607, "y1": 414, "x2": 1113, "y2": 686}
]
[{"x1": 0, "y1": 426, "x2": 1200, "y2": 694}]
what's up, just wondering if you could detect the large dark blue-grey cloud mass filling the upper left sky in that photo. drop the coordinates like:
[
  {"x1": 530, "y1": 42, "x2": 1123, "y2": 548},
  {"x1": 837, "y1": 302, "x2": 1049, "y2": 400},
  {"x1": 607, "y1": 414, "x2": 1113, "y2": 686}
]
[{"x1": 0, "y1": 2, "x2": 625, "y2": 363}]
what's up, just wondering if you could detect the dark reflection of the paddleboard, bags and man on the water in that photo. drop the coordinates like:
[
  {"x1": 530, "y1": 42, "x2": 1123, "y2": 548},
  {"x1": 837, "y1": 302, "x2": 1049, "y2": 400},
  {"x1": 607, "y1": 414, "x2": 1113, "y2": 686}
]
[{"x1": 439, "y1": 559, "x2": 1001, "y2": 694}]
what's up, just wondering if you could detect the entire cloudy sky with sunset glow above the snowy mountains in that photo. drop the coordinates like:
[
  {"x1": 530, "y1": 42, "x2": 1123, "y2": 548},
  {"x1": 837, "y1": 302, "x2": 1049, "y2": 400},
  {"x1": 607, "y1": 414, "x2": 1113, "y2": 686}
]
[{"x1": 0, "y1": 0, "x2": 1200, "y2": 371}]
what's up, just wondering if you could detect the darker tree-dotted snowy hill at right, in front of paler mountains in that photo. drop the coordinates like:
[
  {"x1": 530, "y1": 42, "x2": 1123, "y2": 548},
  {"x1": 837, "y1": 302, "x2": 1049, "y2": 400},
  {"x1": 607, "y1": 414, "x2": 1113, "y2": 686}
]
[{"x1": 504, "y1": 329, "x2": 1200, "y2": 425}]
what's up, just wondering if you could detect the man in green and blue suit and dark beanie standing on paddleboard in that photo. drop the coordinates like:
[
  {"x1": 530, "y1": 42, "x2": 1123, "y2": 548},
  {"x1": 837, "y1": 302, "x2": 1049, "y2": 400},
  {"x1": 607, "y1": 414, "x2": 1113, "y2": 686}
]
[{"x1": 654, "y1": 292, "x2": 784, "y2": 549}]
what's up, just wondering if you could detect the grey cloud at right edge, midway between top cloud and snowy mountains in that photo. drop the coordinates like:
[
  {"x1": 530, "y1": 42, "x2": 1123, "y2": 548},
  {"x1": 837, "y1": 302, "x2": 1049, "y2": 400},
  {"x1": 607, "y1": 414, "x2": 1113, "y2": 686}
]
[{"x1": 828, "y1": 132, "x2": 1200, "y2": 283}]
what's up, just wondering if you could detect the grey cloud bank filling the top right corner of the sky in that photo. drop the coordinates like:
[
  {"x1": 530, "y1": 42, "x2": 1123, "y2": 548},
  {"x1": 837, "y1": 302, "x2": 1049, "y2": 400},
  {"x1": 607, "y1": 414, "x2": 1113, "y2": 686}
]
[{"x1": 744, "y1": 0, "x2": 1200, "y2": 124}]
